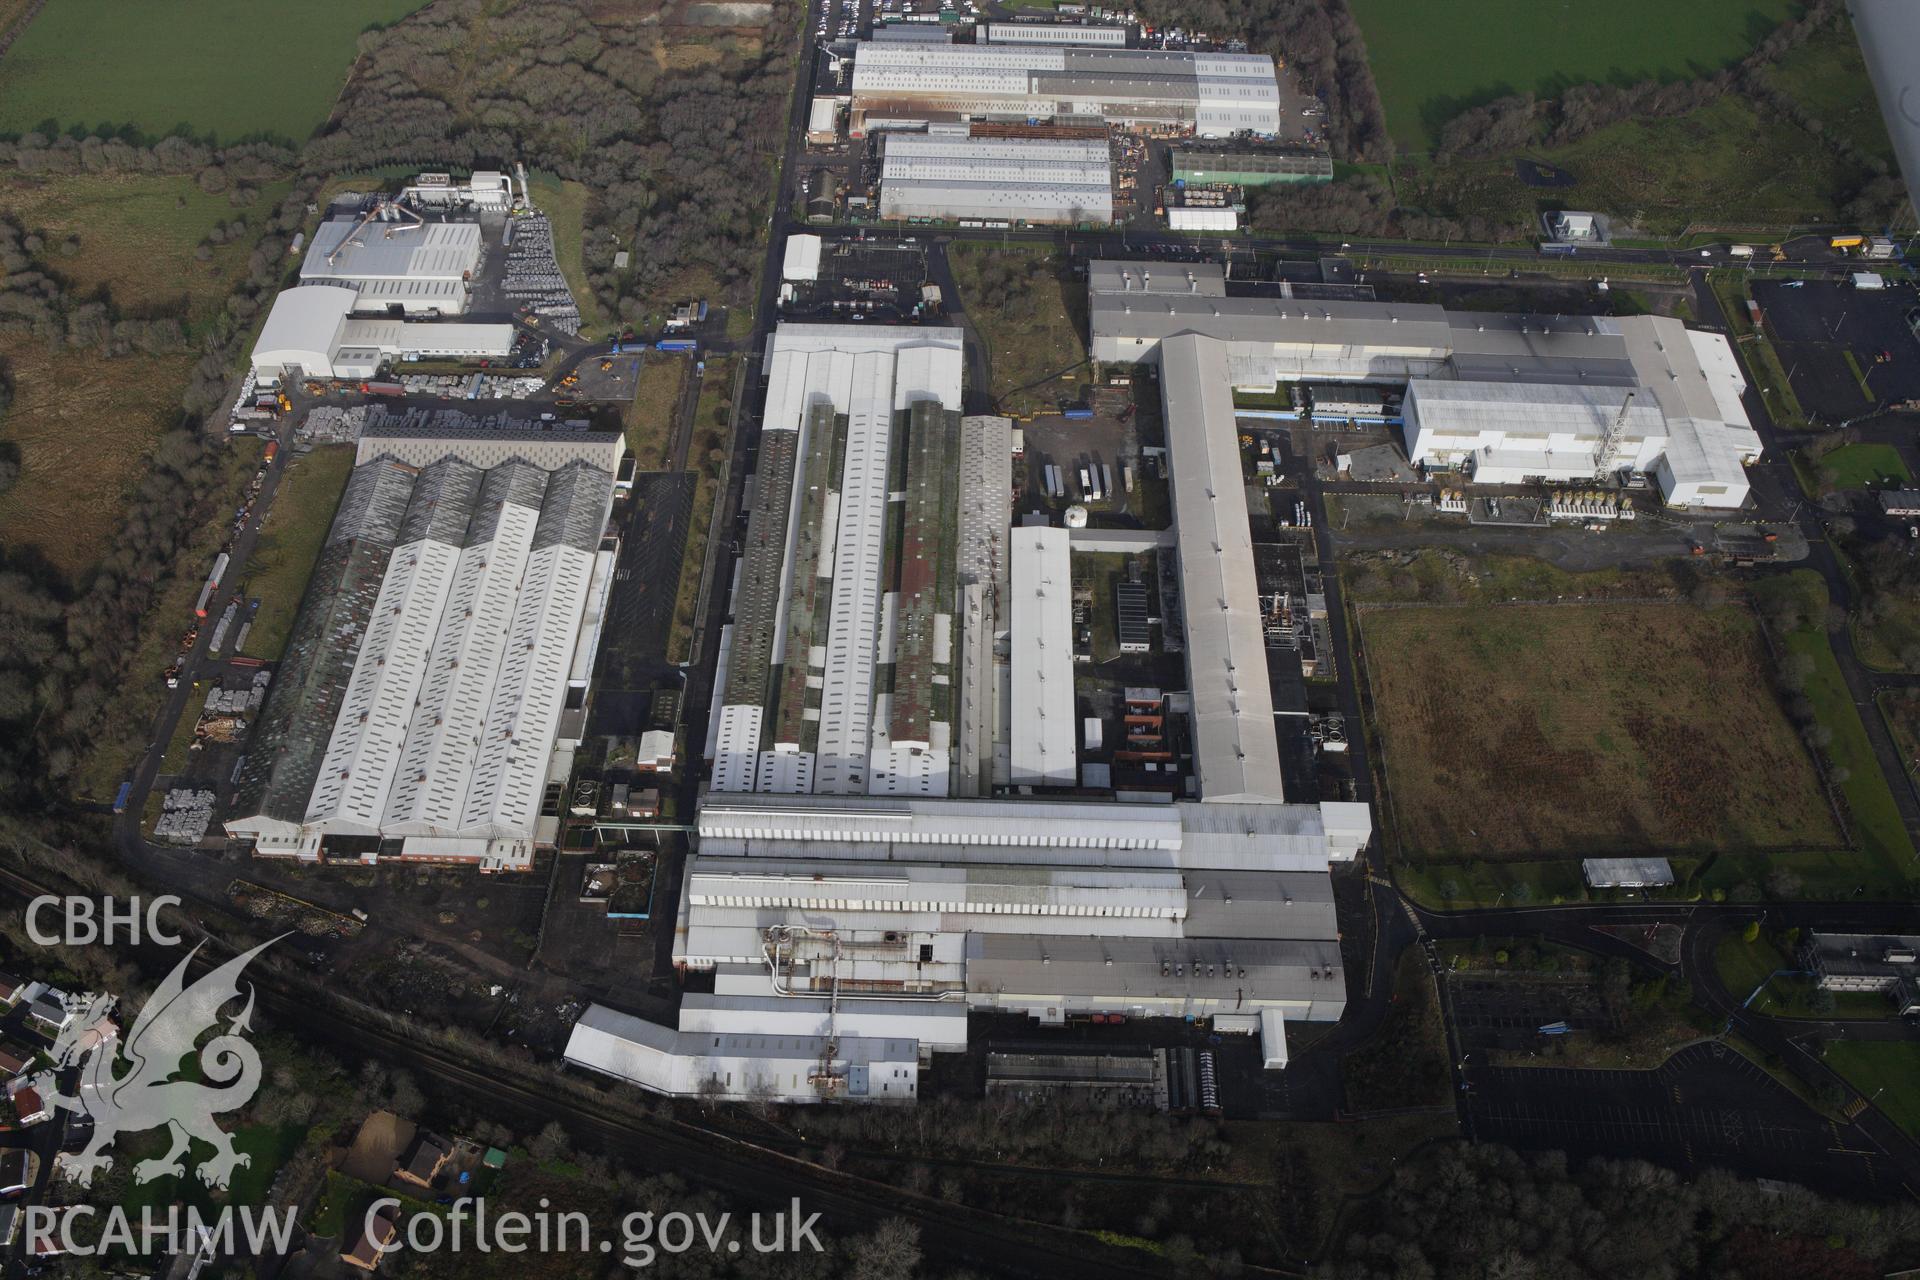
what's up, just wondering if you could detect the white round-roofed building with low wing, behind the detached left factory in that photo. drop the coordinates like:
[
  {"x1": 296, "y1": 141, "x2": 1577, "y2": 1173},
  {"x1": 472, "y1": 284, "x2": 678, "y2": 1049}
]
[{"x1": 252, "y1": 284, "x2": 513, "y2": 386}]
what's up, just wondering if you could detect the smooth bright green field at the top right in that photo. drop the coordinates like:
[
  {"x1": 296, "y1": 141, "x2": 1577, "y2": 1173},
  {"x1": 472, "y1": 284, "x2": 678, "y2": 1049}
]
[{"x1": 1352, "y1": 0, "x2": 1799, "y2": 149}]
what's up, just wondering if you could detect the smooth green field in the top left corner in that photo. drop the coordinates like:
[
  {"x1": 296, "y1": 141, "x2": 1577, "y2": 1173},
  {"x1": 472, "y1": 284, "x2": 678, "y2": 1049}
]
[{"x1": 0, "y1": 0, "x2": 420, "y2": 142}]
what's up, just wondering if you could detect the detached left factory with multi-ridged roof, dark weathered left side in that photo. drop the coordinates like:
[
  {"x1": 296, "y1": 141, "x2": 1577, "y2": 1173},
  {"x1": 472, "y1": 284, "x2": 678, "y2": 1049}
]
[{"x1": 227, "y1": 426, "x2": 620, "y2": 871}]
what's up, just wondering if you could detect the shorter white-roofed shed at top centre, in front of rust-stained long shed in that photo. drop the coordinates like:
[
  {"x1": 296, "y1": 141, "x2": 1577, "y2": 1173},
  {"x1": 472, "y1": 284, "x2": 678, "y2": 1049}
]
[{"x1": 879, "y1": 127, "x2": 1114, "y2": 225}]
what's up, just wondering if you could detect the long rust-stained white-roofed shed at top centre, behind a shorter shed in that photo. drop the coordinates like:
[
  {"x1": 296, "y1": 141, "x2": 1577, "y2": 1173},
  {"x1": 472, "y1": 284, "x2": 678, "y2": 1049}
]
[{"x1": 849, "y1": 40, "x2": 1281, "y2": 138}]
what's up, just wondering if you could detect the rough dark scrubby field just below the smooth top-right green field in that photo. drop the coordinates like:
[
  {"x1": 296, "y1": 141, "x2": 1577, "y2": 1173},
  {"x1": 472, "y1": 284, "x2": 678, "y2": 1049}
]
[{"x1": 1394, "y1": 96, "x2": 1859, "y2": 240}]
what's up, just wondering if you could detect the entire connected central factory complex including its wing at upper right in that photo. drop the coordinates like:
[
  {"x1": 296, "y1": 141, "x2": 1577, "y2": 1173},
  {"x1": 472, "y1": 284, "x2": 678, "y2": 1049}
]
[{"x1": 568, "y1": 247, "x2": 1781, "y2": 1102}]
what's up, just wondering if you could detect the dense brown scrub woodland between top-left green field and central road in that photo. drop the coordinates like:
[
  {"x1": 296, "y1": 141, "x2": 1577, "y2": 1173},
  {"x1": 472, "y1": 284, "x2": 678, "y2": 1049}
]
[{"x1": 303, "y1": 0, "x2": 795, "y2": 320}]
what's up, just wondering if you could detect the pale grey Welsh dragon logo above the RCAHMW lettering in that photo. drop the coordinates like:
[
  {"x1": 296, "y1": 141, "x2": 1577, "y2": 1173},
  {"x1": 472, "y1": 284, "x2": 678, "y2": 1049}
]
[{"x1": 36, "y1": 938, "x2": 278, "y2": 1188}]
